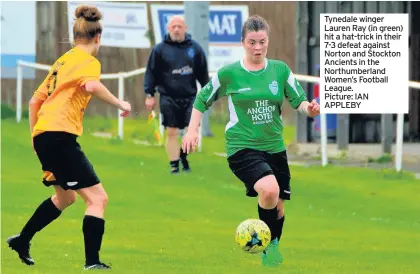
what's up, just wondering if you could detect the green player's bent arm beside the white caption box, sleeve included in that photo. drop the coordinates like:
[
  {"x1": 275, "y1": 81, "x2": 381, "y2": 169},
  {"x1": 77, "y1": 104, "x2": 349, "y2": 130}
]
[{"x1": 284, "y1": 65, "x2": 320, "y2": 117}]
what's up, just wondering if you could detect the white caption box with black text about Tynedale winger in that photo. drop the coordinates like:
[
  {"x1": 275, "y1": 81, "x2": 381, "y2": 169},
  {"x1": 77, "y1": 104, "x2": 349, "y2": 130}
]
[{"x1": 319, "y1": 13, "x2": 409, "y2": 114}]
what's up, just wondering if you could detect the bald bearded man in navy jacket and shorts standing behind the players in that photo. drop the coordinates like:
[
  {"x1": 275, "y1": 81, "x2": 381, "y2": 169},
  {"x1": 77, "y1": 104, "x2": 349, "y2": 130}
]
[{"x1": 144, "y1": 15, "x2": 209, "y2": 173}]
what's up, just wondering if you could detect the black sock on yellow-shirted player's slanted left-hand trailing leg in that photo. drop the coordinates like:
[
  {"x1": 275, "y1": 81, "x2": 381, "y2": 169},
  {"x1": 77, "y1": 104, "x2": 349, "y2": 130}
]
[{"x1": 20, "y1": 198, "x2": 61, "y2": 242}]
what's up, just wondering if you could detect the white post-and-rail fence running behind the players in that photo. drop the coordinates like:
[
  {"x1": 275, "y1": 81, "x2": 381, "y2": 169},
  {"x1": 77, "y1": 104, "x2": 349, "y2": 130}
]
[{"x1": 16, "y1": 60, "x2": 420, "y2": 171}]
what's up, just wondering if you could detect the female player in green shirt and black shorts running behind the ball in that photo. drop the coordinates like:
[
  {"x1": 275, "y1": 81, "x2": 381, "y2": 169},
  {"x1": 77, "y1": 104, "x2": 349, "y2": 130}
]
[{"x1": 182, "y1": 16, "x2": 320, "y2": 266}]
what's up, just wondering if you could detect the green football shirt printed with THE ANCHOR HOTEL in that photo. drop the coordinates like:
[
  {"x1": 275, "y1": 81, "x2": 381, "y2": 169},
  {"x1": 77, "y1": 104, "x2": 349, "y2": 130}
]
[{"x1": 194, "y1": 59, "x2": 307, "y2": 157}]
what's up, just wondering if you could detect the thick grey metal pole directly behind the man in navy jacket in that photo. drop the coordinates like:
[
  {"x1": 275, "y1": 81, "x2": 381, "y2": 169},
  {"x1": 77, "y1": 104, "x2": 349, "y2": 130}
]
[{"x1": 184, "y1": 1, "x2": 213, "y2": 136}]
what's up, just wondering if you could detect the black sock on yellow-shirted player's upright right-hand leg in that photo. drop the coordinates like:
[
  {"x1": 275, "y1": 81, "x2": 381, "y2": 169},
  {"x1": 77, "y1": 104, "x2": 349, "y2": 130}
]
[{"x1": 83, "y1": 215, "x2": 105, "y2": 265}]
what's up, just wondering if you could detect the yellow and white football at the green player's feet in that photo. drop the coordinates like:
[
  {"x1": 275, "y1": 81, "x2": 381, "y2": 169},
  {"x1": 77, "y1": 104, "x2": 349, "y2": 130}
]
[{"x1": 235, "y1": 219, "x2": 271, "y2": 254}]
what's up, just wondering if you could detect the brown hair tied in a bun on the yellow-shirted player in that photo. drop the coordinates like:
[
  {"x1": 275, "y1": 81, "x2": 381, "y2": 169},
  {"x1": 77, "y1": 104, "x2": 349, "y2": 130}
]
[{"x1": 73, "y1": 5, "x2": 102, "y2": 43}]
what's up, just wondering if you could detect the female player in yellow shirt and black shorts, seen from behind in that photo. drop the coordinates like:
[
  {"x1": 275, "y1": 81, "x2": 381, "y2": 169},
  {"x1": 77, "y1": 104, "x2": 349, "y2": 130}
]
[{"x1": 7, "y1": 5, "x2": 131, "y2": 270}]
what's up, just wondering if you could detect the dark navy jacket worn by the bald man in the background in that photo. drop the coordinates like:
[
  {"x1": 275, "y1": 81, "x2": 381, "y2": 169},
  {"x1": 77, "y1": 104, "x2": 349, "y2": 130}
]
[{"x1": 144, "y1": 34, "x2": 209, "y2": 98}]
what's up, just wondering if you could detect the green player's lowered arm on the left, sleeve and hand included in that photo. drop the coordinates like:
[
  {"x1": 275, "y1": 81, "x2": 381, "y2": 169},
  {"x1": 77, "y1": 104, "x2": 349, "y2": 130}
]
[{"x1": 182, "y1": 70, "x2": 226, "y2": 153}]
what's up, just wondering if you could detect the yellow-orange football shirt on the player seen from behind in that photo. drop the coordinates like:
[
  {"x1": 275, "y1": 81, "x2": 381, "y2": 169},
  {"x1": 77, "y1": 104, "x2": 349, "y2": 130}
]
[{"x1": 32, "y1": 47, "x2": 101, "y2": 137}]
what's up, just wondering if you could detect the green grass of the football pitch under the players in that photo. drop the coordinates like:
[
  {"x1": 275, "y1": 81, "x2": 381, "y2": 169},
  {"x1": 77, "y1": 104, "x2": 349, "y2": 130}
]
[{"x1": 1, "y1": 118, "x2": 420, "y2": 274}]
